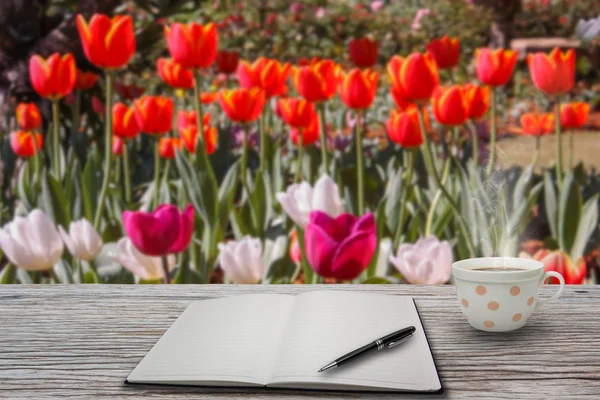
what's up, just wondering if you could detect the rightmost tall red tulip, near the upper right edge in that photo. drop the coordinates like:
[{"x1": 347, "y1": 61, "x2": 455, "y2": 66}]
[{"x1": 527, "y1": 48, "x2": 575, "y2": 95}]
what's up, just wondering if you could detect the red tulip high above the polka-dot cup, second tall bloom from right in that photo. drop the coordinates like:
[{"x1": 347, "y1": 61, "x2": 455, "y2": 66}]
[{"x1": 475, "y1": 47, "x2": 517, "y2": 86}]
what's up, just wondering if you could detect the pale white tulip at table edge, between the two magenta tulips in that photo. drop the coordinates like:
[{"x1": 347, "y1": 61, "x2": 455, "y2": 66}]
[{"x1": 218, "y1": 236, "x2": 265, "y2": 283}]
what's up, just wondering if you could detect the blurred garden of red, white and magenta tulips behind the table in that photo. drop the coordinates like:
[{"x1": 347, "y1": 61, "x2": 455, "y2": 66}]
[{"x1": 0, "y1": 0, "x2": 600, "y2": 284}]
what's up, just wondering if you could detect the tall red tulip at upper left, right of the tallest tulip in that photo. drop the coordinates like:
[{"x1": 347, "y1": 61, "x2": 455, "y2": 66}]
[{"x1": 165, "y1": 22, "x2": 218, "y2": 68}]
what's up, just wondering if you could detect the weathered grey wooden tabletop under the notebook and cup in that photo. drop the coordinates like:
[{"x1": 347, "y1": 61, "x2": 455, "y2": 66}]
[{"x1": 0, "y1": 285, "x2": 600, "y2": 399}]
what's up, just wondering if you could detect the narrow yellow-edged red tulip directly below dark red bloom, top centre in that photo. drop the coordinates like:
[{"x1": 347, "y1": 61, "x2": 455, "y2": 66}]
[{"x1": 340, "y1": 68, "x2": 379, "y2": 110}]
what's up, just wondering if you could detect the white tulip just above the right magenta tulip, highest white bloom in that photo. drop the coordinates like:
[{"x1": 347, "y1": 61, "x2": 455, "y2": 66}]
[{"x1": 276, "y1": 175, "x2": 344, "y2": 229}]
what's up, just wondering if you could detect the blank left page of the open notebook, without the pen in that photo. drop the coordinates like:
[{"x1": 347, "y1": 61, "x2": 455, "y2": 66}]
[{"x1": 127, "y1": 294, "x2": 294, "y2": 386}]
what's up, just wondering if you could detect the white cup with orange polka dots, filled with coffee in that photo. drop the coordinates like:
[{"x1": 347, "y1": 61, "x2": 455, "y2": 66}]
[{"x1": 452, "y1": 257, "x2": 565, "y2": 332}]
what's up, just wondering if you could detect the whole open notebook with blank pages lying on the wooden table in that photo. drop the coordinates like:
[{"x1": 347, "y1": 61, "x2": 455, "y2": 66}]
[{"x1": 127, "y1": 291, "x2": 442, "y2": 392}]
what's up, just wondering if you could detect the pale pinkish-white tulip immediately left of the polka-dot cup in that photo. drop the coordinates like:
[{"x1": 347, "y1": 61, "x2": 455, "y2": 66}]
[{"x1": 390, "y1": 236, "x2": 453, "y2": 285}]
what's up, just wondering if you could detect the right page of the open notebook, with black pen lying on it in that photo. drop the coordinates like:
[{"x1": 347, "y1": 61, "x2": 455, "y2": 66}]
[{"x1": 267, "y1": 291, "x2": 441, "y2": 391}]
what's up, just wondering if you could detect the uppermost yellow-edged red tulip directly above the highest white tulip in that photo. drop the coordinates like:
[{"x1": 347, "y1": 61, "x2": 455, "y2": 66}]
[{"x1": 292, "y1": 60, "x2": 340, "y2": 102}]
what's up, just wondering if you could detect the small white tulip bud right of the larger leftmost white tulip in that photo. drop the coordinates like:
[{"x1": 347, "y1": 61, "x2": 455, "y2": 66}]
[{"x1": 58, "y1": 218, "x2": 104, "y2": 261}]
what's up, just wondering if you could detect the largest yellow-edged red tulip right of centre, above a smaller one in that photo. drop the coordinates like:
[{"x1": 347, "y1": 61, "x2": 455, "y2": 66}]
[{"x1": 387, "y1": 53, "x2": 440, "y2": 103}]
